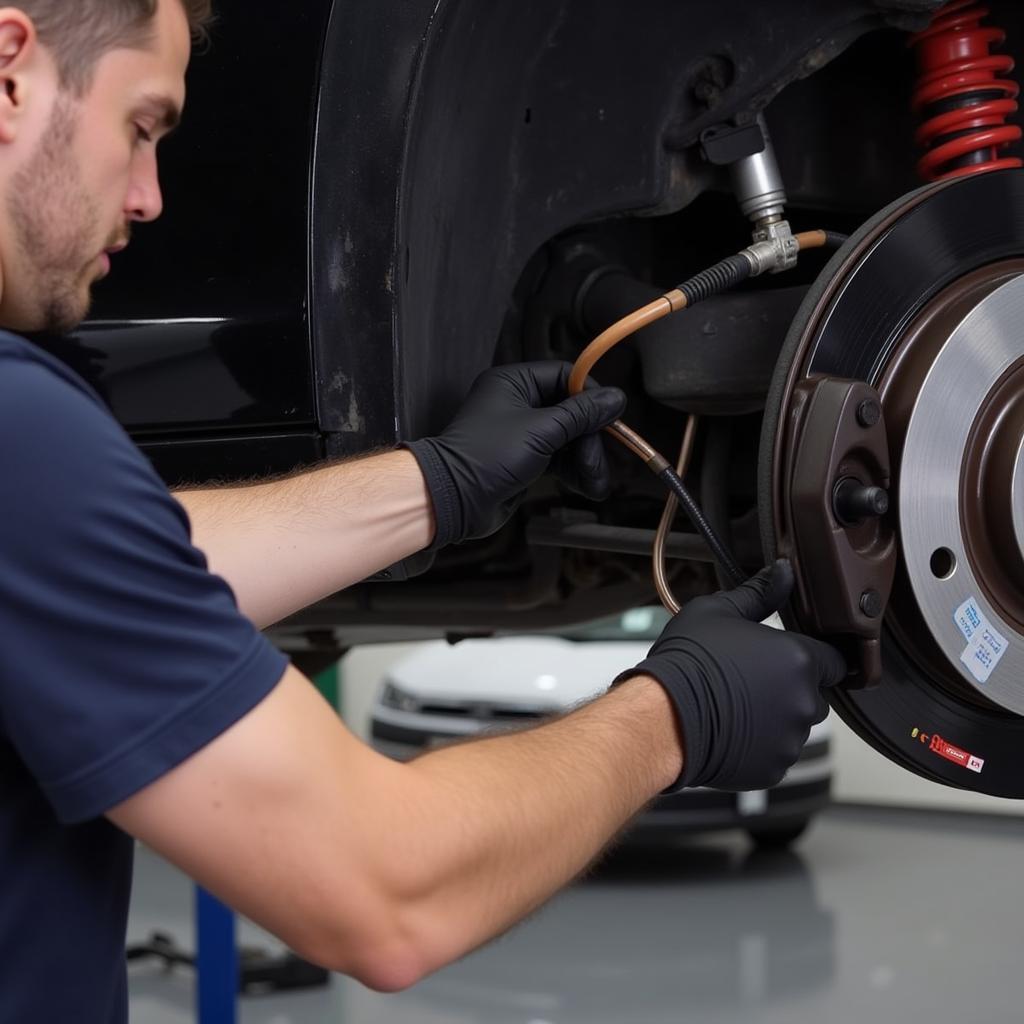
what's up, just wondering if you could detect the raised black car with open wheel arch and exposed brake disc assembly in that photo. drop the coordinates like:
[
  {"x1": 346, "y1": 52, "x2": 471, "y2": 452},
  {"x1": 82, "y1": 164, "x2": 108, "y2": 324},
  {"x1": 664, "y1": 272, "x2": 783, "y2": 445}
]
[{"x1": 75, "y1": 0, "x2": 1024, "y2": 796}]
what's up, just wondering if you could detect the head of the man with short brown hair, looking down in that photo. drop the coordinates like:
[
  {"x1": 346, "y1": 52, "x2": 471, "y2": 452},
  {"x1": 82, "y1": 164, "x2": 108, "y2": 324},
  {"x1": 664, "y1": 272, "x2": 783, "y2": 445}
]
[{"x1": 0, "y1": 0, "x2": 210, "y2": 331}]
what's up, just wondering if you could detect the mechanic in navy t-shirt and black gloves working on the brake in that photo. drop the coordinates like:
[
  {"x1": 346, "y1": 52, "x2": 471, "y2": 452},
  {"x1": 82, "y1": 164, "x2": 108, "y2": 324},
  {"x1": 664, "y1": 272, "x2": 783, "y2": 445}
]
[{"x1": 0, "y1": 0, "x2": 845, "y2": 1024}]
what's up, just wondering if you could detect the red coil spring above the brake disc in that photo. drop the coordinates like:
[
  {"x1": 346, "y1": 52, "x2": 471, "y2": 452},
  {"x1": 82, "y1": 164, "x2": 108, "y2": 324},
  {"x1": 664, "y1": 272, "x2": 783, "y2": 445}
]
[{"x1": 909, "y1": 0, "x2": 1022, "y2": 181}]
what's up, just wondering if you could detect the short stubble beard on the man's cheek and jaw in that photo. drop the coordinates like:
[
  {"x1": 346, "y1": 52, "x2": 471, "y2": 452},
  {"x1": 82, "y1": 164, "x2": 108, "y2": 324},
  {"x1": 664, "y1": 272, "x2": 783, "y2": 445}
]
[{"x1": 5, "y1": 98, "x2": 100, "y2": 333}]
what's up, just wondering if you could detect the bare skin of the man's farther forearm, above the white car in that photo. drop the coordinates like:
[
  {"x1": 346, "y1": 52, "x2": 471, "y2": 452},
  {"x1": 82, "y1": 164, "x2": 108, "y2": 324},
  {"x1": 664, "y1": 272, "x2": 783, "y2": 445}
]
[{"x1": 175, "y1": 452, "x2": 434, "y2": 627}]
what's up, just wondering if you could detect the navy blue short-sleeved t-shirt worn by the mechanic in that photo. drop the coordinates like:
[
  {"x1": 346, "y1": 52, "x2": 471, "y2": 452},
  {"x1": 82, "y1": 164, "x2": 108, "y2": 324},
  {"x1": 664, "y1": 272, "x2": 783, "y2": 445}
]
[{"x1": 0, "y1": 333, "x2": 286, "y2": 1024}]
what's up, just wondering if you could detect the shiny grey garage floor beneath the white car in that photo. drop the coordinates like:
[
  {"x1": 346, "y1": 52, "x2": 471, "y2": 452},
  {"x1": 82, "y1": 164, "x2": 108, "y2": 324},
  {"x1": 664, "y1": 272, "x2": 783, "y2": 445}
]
[{"x1": 129, "y1": 808, "x2": 1024, "y2": 1024}]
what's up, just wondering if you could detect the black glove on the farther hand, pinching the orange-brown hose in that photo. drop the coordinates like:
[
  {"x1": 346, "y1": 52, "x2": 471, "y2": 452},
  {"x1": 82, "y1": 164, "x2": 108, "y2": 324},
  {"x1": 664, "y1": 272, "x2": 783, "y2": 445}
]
[{"x1": 403, "y1": 362, "x2": 626, "y2": 548}]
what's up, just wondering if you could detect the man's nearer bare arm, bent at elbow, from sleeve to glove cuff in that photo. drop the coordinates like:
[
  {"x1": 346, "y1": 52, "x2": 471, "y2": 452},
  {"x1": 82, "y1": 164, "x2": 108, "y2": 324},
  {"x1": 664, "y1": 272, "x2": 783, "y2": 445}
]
[{"x1": 110, "y1": 669, "x2": 682, "y2": 990}]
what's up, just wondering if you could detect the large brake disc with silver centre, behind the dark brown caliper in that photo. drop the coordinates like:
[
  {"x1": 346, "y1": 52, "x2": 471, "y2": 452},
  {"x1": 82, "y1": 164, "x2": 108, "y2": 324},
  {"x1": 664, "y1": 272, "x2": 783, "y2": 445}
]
[{"x1": 759, "y1": 170, "x2": 1024, "y2": 798}]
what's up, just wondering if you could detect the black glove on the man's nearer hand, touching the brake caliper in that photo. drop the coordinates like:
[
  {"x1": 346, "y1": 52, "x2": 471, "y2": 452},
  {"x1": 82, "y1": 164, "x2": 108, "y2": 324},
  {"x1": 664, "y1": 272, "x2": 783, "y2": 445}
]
[{"x1": 615, "y1": 560, "x2": 847, "y2": 793}]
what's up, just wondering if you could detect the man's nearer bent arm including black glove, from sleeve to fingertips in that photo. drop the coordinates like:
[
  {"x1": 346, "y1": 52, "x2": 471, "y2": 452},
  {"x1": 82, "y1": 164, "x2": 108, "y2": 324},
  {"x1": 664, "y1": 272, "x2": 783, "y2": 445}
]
[{"x1": 110, "y1": 562, "x2": 846, "y2": 989}]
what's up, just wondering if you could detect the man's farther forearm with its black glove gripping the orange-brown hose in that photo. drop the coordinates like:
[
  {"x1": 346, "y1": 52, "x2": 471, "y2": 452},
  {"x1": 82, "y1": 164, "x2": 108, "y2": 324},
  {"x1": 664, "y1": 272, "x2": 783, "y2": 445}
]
[{"x1": 175, "y1": 362, "x2": 626, "y2": 627}]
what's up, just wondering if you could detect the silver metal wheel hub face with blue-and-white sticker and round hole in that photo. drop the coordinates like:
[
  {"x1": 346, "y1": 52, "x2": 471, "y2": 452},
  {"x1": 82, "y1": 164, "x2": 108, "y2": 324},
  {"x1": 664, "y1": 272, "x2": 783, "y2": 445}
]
[{"x1": 883, "y1": 276, "x2": 1024, "y2": 714}]
